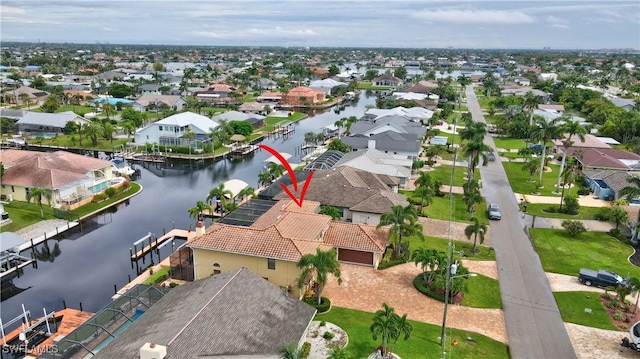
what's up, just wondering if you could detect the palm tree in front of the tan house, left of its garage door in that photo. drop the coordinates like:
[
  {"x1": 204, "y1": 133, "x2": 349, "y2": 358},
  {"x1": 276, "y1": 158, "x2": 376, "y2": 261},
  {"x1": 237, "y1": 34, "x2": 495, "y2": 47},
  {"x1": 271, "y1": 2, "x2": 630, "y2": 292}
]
[{"x1": 298, "y1": 247, "x2": 342, "y2": 305}]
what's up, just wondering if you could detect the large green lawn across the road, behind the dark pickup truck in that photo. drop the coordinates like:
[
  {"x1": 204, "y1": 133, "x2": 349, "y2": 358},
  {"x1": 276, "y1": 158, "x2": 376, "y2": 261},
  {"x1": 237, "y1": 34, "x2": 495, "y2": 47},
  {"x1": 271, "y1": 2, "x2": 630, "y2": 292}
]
[{"x1": 530, "y1": 228, "x2": 640, "y2": 278}]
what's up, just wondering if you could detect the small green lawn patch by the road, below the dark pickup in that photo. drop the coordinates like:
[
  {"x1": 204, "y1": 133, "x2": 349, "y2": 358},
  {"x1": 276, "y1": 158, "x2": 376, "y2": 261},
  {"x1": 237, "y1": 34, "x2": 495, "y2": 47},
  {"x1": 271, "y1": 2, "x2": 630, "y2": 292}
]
[{"x1": 553, "y1": 292, "x2": 618, "y2": 330}]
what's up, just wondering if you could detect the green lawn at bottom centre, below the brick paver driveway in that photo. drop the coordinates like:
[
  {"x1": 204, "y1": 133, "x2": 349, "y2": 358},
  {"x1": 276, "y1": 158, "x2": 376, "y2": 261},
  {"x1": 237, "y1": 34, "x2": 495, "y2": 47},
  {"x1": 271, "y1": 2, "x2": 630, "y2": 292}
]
[{"x1": 315, "y1": 306, "x2": 509, "y2": 358}]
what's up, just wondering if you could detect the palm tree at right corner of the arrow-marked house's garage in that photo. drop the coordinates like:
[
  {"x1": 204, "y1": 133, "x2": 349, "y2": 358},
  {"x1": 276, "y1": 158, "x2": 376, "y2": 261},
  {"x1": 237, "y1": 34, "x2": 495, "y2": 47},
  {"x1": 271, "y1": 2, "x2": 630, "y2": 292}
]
[{"x1": 377, "y1": 204, "x2": 424, "y2": 259}]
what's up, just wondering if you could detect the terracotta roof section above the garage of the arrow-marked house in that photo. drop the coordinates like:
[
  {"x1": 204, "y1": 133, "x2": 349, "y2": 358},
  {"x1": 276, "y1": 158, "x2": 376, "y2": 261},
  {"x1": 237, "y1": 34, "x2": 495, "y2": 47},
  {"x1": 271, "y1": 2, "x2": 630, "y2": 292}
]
[{"x1": 324, "y1": 222, "x2": 389, "y2": 252}]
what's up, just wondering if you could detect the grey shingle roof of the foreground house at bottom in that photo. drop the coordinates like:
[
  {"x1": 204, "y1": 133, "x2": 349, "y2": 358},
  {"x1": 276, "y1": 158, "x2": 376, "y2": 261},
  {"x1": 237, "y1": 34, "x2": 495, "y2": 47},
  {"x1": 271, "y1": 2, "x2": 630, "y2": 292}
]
[{"x1": 94, "y1": 268, "x2": 316, "y2": 359}]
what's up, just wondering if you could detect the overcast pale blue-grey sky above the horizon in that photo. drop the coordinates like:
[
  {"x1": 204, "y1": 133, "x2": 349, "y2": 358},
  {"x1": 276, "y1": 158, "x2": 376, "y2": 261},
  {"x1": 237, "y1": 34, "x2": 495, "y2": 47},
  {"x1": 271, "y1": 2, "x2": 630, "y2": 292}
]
[{"x1": 0, "y1": 0, "x2": 640, "y2": 49}]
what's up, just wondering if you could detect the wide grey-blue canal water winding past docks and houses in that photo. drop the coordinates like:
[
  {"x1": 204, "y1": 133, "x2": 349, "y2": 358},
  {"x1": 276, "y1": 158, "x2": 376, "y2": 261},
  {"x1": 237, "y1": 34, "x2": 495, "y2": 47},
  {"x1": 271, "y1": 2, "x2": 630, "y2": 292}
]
[{"x1": 1, "y1": 92, "x2": 376, "y2": 322}]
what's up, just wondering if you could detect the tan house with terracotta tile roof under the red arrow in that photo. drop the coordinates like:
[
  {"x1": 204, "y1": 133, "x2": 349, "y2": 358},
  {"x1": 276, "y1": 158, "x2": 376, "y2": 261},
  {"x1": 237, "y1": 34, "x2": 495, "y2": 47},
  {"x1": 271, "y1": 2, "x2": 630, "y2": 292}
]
[{"x1": 185, "y1": 198, "x2": 389, "y2": 288}]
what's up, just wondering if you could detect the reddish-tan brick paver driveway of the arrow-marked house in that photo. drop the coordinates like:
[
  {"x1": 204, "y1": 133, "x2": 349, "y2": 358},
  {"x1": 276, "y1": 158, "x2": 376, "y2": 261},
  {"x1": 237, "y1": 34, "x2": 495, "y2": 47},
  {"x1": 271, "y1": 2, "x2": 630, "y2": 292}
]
[{"x1": 322, "y1": 261, "x2": 507, "y2": 343}]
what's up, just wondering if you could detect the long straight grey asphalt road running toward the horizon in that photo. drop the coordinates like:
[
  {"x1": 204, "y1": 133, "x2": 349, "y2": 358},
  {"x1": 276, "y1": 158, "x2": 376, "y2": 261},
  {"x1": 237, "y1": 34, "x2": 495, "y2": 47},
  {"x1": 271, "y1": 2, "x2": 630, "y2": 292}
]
[{"x1": 466, "y1": 86, "x2": 576, "y2": 359}]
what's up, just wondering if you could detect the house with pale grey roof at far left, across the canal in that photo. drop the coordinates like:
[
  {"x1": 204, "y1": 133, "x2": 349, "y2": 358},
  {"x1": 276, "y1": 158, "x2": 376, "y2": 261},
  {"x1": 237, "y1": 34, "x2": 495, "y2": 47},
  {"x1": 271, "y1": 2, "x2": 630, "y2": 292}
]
[{"x1": 16, "y1": 111, "x2": 89, "y2": 137}]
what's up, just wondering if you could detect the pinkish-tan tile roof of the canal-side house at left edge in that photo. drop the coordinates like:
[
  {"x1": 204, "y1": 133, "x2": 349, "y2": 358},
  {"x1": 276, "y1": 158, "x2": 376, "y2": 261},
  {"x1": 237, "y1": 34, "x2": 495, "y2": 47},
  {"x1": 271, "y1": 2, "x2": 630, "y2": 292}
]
[{"x1": 1, "y1": 150, "x2": 112, "y2": 189}]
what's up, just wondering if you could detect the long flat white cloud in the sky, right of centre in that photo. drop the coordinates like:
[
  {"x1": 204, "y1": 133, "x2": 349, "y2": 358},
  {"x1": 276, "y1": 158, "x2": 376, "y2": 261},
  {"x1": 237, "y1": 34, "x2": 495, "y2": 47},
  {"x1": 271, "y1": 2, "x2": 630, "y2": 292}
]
[{"x1": 411, "y1": 8, "x2": 536, "y2": 25}]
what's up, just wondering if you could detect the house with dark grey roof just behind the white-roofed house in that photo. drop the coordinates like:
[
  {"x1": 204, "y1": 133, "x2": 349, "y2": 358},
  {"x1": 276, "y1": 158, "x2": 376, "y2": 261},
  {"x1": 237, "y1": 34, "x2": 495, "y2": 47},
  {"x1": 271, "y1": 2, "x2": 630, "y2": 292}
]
[{"x1": 340, "y1": 131, "x2": 422, "y2": 160}]
